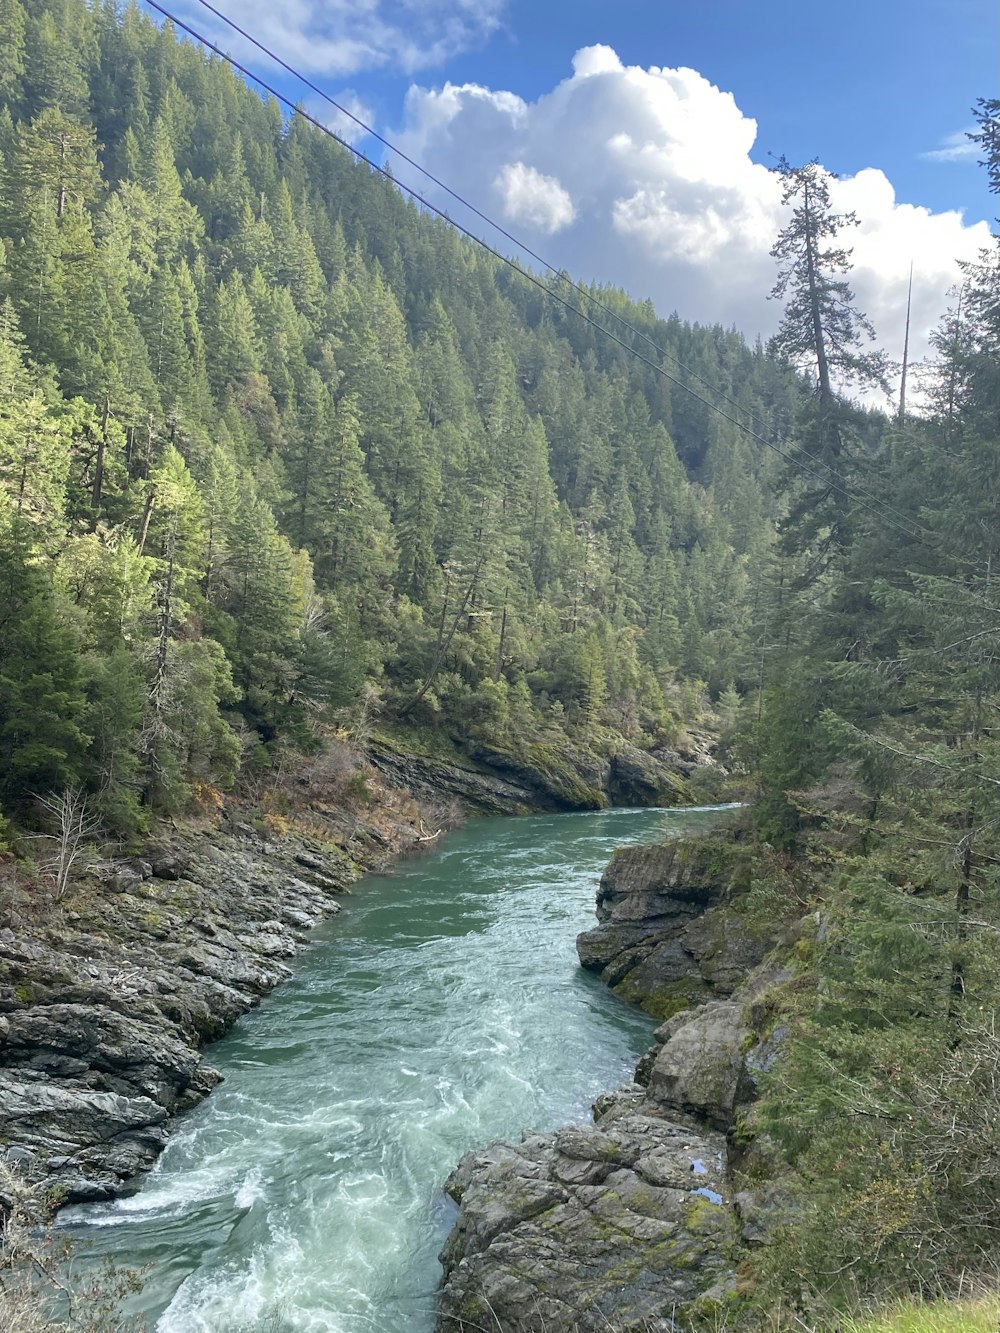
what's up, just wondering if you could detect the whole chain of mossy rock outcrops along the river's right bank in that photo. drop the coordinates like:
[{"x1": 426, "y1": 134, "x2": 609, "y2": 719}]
[{"x1": 439, "y1": 837, "x2": 784, "y2": 1333}]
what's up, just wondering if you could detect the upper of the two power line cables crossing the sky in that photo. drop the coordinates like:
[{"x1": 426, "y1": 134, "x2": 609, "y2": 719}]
[{"x1": 189, "y1": 0, "x2": 932, "y2": 546}]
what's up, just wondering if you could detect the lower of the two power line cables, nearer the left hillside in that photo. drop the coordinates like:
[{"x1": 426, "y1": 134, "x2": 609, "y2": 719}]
[{"x1": 145, "y1": 0, "x2": 927, "y2": 544}]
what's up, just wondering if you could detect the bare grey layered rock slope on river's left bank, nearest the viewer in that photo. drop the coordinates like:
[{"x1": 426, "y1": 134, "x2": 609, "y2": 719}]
[{"x1": 0, "y1": 829, "x2": 385, "y2": 1201}]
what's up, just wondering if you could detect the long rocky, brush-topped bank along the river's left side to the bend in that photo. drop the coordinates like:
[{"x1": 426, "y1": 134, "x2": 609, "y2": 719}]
[{"x1": 0, "y1": 741, "x2": 714, "y2": 1204}]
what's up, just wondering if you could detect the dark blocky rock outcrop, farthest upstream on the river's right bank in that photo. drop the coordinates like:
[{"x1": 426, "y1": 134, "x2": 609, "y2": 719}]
[{"x1": 576, "y1": 837, "x2": 765, "y2": 1018}]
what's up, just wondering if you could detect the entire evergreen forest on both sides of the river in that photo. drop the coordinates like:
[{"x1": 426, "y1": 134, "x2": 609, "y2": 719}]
[{"x1": 0, "y1": 0, "x2": 1000, "y2": 1308}]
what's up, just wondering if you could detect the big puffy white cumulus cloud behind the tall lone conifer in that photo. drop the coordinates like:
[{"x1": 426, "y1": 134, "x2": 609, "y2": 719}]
[{"x1": 395, "y1": 45, "x2": 989, "y2": 399}]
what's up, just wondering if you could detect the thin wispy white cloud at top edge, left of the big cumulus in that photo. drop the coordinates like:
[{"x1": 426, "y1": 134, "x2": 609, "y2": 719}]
[{"x1": 168, "y1": 0, "x2": 507, "y2": 76}]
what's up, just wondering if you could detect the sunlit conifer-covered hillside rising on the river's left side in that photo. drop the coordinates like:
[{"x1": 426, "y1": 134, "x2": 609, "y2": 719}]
[{"x1": 0, "y1": 0, "x2": 800, "y2": 832}]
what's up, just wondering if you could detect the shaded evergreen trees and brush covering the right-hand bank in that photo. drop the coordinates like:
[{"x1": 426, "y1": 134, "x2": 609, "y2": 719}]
[{"x1": 729, "y1": 101, "x2": 1000, "y2": 1329}]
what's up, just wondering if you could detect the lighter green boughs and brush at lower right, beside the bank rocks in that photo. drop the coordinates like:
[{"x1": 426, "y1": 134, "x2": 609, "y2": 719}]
[{"x1": 755, "y1": 876, "x2": 1000, "y2": 1306}]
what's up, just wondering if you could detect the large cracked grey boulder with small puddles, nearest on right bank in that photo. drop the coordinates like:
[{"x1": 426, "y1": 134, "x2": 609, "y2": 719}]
[{"x1": 439, "y1": 1085, "x2": 737, "y2": 1333}]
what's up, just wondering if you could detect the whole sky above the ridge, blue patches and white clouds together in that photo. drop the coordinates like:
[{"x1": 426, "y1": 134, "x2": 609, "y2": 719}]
[{"x1": 154, "y1": 0, "x2": 1000, "y2": 389}]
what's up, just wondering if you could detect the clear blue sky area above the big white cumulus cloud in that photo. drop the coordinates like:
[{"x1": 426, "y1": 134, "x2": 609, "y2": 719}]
[{"x1": 365, "y1": 0, "x2": 1000, "y2": 221}]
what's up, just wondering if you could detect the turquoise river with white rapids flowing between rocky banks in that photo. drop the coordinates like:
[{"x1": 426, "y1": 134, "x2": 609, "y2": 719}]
[{"x1": 61, "y1": 809, "x2": 736, "y2": 1333}]
